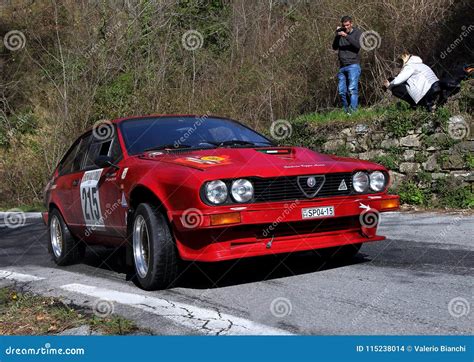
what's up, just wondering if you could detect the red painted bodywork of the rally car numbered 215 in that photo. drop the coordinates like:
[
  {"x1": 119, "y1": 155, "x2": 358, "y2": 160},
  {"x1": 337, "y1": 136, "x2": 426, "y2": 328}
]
[{"x1": 43, "y1": 116, "x2": 399, "y2": 262}]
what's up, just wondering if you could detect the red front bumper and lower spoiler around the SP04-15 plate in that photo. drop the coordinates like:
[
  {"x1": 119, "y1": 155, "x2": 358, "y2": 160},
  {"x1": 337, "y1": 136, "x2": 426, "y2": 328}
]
[{"x1": 169, "y1": 194, "x2": 399, "y2": 261}]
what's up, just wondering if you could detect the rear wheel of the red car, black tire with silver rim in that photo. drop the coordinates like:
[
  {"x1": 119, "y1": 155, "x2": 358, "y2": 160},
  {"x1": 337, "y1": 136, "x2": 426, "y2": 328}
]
[{"x1": 48, "y1": 209, "x2": 86, "y2": 266}]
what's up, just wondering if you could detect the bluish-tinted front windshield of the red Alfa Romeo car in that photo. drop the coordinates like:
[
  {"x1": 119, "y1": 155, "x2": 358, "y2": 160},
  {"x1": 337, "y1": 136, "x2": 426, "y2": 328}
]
[{"x1": 120, "y1": 117, "x2": 272, "y2": 155}]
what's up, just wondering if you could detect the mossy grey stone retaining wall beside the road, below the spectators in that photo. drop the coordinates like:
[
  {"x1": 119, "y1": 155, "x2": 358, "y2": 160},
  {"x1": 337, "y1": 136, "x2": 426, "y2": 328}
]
[{"x1": 320, "y1": 116, "x2": 474, "y2": 191}]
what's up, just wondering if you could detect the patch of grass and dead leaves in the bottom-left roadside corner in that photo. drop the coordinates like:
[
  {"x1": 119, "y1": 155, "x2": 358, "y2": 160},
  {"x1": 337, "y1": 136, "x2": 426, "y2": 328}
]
[{"x1": 0, "y1": 287, "x2": 138, "y2": 335}]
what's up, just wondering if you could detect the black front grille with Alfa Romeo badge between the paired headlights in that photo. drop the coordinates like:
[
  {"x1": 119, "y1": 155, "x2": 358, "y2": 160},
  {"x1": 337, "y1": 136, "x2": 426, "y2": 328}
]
[{"x1": 251, "y1": 173, "x2": 352, "y2": 202}]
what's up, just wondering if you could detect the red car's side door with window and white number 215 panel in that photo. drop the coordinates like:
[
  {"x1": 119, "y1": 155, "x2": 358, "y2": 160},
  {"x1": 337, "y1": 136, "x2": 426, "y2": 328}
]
[{"x1": 77, "y1": 130, "x2": 126, "y2": 241}]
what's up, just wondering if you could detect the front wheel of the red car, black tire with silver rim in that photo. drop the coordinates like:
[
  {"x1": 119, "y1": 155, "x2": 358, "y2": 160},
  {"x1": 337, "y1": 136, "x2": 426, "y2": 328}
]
[{"x1": 130, "y1": 203, "x2": 180, "y2": 290}]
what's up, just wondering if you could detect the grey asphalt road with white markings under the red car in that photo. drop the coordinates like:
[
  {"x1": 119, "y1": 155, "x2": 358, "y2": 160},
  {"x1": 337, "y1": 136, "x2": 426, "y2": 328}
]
[{"x1": 0, "y1": 213, "x2": 474, "y2": 335}]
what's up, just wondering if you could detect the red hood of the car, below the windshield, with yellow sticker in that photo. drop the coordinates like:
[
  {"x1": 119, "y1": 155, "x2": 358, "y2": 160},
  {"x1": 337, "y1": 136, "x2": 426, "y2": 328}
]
[{"x1": 141, "y1": 147, "x2": 384, "y2": 178}]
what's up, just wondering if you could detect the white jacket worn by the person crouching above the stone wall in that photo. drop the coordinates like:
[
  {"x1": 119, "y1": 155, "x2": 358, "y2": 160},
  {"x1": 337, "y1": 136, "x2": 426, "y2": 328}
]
[{"x1": 390, "y1": 55, "x2": 439, "y2": 103}]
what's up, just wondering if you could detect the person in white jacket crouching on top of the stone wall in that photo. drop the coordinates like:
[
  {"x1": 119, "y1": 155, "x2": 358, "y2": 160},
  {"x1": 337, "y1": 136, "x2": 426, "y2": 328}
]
[{"x1": 384, "y1": 52, "x2": 441, "y2": 112}]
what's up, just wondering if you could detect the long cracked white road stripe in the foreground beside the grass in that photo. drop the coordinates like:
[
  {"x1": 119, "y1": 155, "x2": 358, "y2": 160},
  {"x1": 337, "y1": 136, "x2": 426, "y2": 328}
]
[{"x1": 61, "y1": 283, "x2": 291, "y2": 335}]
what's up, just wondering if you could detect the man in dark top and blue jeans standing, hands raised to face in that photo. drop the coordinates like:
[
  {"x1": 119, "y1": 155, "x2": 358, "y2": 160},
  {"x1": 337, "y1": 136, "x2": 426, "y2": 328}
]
[{"x1": 332, "y1": 15, "x2": 362, "y2": 114}]
